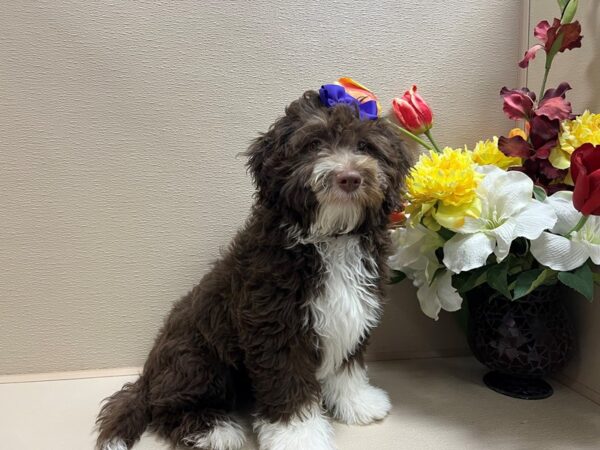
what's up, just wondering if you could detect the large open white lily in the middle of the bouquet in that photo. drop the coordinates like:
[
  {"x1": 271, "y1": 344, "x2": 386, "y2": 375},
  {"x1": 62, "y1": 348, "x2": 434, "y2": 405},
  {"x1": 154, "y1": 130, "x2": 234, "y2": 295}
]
[{"x1": 444, "y1": 166, "x2": 556, "y2": 273}]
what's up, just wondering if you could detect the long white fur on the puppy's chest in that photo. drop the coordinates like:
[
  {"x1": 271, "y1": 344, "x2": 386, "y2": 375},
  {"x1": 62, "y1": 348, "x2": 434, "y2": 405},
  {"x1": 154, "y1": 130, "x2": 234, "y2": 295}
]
[{"x1": 311, "y1": 236, "x2": 380, "y2": 379}]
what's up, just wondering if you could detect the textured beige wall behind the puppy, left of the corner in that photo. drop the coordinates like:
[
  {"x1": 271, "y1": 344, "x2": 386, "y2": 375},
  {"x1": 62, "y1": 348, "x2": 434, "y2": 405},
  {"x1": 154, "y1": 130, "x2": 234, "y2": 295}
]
[{"x1": 0, "y1": 0, "x2": 522, "y2": 373}]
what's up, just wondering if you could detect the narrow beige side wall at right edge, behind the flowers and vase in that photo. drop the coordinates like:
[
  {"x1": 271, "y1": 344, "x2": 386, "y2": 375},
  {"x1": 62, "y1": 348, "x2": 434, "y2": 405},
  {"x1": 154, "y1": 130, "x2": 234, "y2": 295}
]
[{"x1": 529, "y1": 0, "x2": 600, "y2": 403}]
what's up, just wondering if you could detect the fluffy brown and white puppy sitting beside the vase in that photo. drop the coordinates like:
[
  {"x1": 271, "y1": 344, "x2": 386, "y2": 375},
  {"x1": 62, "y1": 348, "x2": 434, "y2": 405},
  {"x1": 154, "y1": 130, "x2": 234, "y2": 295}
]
[{"x1": 97, "y1": 91, "x2": 410, "y2": 450}]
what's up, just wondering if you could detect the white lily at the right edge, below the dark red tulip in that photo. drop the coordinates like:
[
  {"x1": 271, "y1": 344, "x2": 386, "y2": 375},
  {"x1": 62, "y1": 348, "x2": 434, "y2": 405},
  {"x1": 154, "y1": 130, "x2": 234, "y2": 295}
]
[{"x1": 531, "y1": 191, "x2": 600, "y2": 271}]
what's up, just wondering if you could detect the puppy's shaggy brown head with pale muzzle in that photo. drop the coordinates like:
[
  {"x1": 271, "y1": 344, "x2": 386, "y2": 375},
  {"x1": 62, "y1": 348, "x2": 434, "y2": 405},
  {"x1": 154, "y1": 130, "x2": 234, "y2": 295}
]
[{"x1": 247, "y1": 91, "x2": 410, "y2": 236}]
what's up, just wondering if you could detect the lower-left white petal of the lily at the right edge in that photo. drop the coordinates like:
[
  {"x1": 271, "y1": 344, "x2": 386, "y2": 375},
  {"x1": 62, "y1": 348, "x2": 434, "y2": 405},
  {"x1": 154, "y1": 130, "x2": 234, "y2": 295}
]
[{"x1": 530, "y1": 232, "x2": 590, "y2": 271}]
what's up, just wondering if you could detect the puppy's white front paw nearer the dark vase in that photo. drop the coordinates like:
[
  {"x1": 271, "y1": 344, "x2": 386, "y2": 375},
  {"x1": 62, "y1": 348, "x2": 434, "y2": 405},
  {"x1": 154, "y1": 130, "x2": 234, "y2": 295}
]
[{"x1": 330, "y1": 384, "x2": 392, "y2": 425}]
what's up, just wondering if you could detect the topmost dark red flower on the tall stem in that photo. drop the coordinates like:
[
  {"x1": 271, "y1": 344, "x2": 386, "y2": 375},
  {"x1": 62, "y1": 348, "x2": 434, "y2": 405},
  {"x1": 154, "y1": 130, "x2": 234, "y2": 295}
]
[{"x1": 519, "y1": 19, "x2": 583, "y2": 69}]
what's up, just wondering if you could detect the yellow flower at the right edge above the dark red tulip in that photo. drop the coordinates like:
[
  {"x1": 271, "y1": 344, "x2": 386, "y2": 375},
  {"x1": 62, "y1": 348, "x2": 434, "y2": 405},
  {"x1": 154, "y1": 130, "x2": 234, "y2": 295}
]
[{"x1": 549, "y1": 110, "x2": 600, "y2": 169}]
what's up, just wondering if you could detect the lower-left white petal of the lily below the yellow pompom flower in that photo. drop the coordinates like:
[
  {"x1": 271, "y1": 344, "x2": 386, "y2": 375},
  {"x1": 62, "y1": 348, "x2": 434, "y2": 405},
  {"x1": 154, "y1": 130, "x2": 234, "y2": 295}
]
[{"x1": 444, "y1": 233, "x2": 495, "y2": 273}]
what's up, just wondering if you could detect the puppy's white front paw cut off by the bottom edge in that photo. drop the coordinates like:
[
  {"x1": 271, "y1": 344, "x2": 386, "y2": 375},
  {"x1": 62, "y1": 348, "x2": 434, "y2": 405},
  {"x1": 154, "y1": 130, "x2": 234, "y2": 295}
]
[{"x1": 254, "y1": 407, "x2": 336, "y2": 450}]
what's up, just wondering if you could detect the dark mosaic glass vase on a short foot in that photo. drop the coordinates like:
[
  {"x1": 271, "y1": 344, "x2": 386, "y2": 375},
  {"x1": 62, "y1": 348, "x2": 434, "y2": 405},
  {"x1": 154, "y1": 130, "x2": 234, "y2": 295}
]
[{"x1": 467, "y1": 286, "x2": 575, "y2": 400}]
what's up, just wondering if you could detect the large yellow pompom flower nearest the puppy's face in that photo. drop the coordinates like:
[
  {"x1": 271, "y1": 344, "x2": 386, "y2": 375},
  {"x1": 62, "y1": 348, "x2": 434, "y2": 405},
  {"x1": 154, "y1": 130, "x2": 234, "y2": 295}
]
[{"x1": 406, "y1": 147, "x2": 483, "y2": 229}]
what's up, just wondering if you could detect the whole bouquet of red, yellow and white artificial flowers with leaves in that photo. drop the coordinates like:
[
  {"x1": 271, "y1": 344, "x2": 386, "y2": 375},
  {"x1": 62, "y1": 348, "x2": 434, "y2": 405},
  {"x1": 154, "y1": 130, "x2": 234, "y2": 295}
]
[{"x1": 384, "y1": 0, "x2": 600, "y2": 319}]
